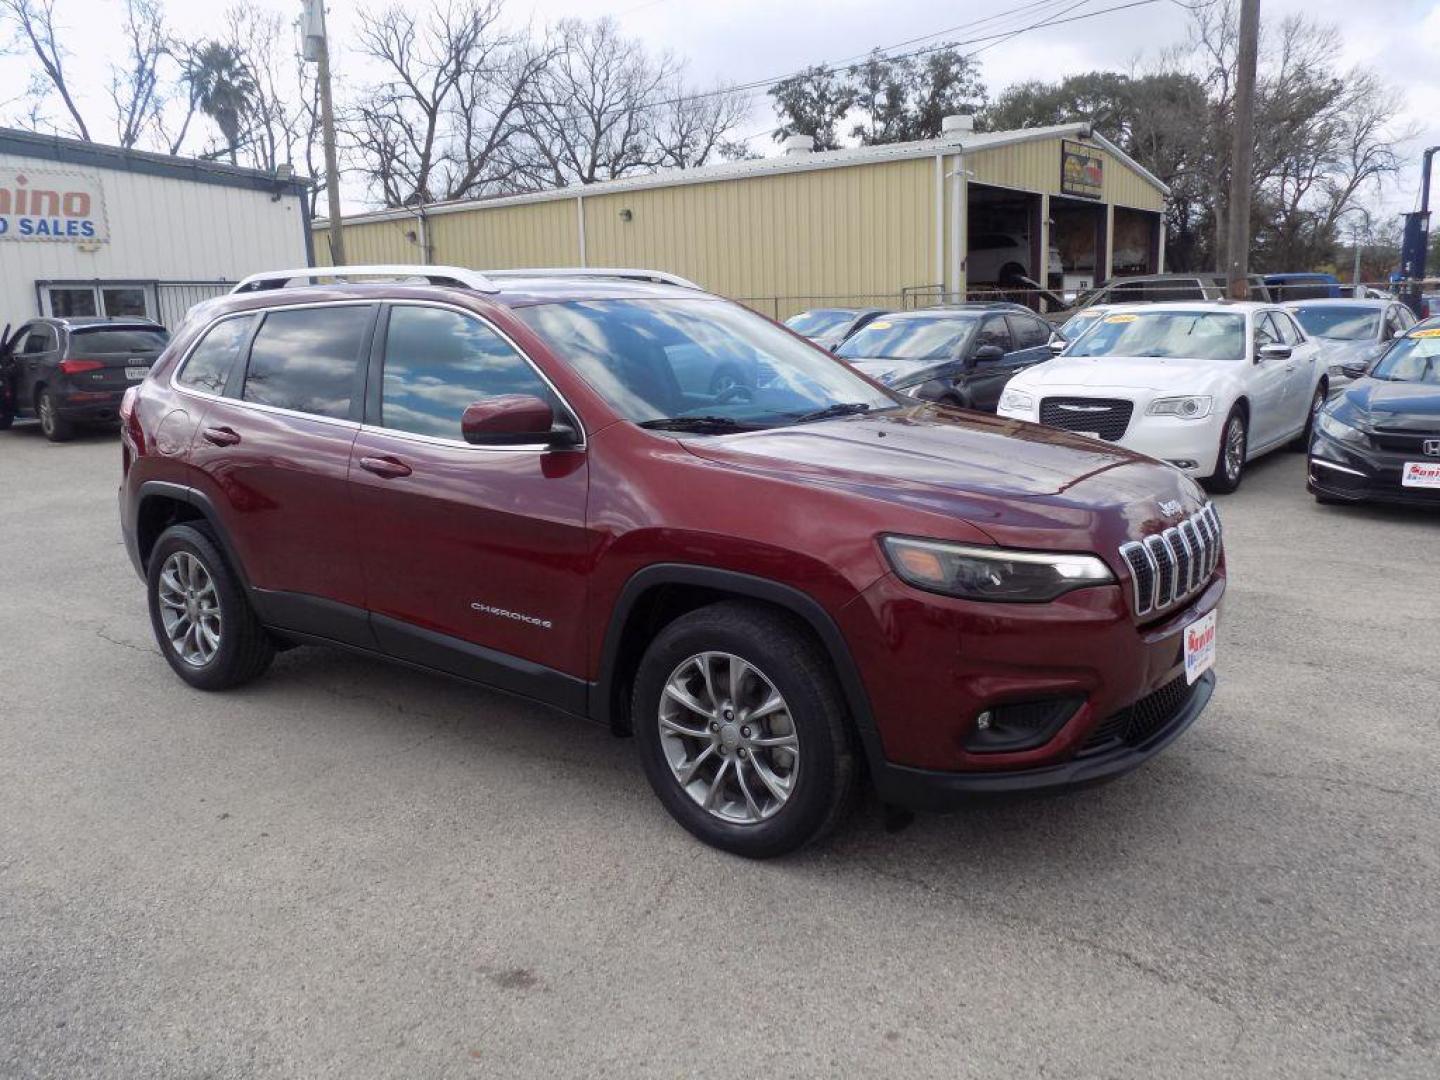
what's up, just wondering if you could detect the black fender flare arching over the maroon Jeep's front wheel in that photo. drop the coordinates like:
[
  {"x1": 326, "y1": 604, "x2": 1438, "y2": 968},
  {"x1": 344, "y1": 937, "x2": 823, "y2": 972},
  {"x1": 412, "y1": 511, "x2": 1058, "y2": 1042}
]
[{"x1": 589, "y1": 563, "x2": 886, "y2": 773}]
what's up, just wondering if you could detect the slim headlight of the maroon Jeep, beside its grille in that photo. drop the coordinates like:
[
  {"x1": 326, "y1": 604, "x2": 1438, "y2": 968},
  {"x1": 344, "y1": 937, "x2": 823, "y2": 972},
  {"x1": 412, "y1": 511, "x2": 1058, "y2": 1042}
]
[{"x1": 884, "y1": 536, "x2": 1115, "y2": 603}]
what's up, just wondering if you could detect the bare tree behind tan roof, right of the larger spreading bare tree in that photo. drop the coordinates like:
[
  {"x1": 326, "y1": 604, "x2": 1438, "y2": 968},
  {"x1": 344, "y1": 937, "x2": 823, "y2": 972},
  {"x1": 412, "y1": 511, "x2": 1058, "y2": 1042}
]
[{"x1": 523, "y1": 19, "x2": 680, "y2": 187}]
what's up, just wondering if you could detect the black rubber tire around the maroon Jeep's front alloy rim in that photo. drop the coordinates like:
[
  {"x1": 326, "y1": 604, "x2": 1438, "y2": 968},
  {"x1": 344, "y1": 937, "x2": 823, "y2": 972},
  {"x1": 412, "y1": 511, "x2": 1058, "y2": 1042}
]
[{"x1": 631, "y1": 605, "x2": 852, "y2": 858}]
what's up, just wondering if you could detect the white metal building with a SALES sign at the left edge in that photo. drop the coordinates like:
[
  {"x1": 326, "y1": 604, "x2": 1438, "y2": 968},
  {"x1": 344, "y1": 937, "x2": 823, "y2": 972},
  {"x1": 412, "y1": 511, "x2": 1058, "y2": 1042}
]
[{"x1": 0, "y1": 128, "x2": 310, "y2": 327}]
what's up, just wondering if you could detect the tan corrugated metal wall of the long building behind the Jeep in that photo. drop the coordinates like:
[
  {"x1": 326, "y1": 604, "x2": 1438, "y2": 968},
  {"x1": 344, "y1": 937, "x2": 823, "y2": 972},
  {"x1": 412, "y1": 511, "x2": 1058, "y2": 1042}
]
[{"x1": 315, "y1": 138, "x2": 1164, "y2": 318}]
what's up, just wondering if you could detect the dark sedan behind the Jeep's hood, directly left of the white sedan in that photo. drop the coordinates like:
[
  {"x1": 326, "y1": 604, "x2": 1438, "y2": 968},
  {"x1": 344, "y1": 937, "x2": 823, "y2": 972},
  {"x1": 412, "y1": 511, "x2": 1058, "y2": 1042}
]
[{"x1": 835, "y1": 302, "x2": 1054, "y2": 412}]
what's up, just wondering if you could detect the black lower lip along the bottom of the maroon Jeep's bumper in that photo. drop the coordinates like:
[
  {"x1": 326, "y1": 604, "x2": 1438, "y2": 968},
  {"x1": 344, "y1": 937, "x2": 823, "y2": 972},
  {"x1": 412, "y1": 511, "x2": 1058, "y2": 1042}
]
[{"x1": 876, "y1": 671, "x2": 1215, "y2": 811}]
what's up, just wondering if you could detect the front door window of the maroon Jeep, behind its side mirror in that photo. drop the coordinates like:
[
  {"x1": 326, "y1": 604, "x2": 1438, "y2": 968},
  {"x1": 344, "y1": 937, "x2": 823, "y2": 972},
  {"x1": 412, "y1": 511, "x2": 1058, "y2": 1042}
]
[{"x1": 380, "y1": 307, "x2": 560, "y2": 439}]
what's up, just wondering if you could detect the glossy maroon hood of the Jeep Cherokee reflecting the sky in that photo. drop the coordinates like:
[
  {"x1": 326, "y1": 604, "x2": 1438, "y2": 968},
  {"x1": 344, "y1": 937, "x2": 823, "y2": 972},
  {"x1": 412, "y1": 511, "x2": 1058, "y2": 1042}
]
[{"x1": 684, "y1": 405, "x2": 1204, "y2": 550}]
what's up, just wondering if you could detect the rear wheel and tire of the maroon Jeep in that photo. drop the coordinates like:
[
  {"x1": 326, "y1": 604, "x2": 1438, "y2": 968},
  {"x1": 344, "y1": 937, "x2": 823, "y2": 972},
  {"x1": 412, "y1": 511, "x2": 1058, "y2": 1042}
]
[{"x1": 145, "y1": 526, "x2": 275, "y2": 690}]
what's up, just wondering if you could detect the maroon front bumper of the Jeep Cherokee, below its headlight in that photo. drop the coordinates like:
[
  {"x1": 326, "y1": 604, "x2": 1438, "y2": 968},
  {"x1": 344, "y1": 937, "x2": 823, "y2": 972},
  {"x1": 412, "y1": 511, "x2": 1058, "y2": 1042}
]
[{"x1": 838, "y1": 559, "x2": 1225, "y2": 805}]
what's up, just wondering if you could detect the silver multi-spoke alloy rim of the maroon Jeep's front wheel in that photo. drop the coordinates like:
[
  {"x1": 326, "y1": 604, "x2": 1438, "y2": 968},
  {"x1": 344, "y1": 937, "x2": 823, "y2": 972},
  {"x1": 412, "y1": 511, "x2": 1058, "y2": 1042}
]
[{"x1": 658, "y1": 652, "x2": 801, "y2": 825}]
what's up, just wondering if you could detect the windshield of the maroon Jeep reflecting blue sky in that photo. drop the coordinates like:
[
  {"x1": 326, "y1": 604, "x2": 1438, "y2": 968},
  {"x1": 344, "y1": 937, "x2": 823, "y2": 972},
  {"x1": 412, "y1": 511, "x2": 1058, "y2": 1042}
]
[{"x1": 516, "y1": 300, "x2": 897, "y2": 431}]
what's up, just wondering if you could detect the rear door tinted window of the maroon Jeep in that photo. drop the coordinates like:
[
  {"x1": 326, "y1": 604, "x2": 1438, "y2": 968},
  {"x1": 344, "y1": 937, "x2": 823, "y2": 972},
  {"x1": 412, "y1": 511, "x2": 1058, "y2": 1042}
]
[{"x1": 242, "y1": 307, "x2": 372, "y2": 419}]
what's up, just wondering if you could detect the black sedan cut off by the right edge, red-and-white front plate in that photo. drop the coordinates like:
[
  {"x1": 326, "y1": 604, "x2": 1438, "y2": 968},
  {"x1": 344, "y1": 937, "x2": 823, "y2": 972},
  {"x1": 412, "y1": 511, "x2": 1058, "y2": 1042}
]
[{"x1": 1306, "y1": 320, "x2": 1440, "y2": 505}]
